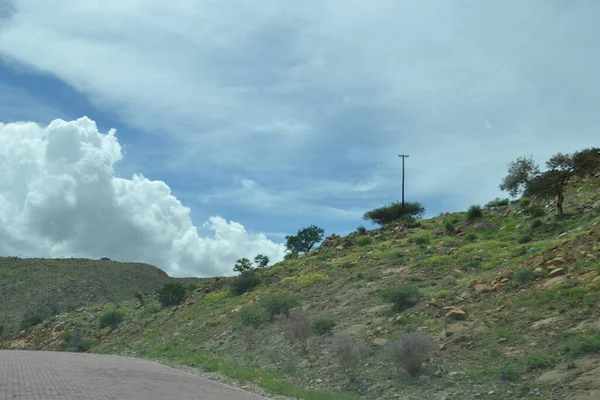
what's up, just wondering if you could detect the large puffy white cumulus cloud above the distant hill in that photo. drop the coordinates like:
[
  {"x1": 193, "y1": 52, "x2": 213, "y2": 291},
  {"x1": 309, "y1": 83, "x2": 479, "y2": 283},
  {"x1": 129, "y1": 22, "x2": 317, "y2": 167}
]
[{"x1": 0, "y1": 117, "x2": 285, "y2": 276}]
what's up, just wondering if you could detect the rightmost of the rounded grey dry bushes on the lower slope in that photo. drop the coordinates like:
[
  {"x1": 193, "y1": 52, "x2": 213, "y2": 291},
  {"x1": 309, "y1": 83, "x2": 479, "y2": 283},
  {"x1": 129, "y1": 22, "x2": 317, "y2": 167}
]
[{"x1": 387, "y1": 331, "x2": 433, "y2": 376}]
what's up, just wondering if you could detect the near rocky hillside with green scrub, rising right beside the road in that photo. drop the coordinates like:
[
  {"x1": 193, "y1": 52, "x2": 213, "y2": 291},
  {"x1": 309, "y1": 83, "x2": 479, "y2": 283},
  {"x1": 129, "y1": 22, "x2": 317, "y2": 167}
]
[{"x1": 0, "y1": 176, "x2": 600, "y2": 400}]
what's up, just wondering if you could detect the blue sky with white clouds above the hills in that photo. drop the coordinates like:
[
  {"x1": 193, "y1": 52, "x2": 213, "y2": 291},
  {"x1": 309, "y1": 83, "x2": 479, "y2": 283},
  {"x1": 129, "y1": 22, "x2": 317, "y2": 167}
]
[{"x1": 0, "y1": 0, "x2": 600, "y2": 276}]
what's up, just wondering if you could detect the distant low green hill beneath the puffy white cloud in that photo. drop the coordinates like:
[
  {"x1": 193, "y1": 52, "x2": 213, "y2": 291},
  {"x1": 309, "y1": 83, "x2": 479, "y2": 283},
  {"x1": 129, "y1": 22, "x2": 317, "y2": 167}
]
[{"x1": 0, "y1": 257, "x2": 170, "y2": 335}]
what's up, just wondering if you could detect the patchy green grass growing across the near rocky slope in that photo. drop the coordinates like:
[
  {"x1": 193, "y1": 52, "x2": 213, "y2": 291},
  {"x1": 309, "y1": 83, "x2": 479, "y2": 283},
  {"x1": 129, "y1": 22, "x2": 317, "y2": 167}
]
[{"x1": 0, "y1": 178, "x2": 600, "y2": 399}]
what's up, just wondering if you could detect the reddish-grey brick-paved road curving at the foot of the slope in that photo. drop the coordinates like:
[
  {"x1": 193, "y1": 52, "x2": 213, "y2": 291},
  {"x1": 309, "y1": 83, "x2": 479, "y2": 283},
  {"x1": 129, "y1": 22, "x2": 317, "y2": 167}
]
[{"x1": 0, "y1": 350, "x2": 263, "y2": 400}]
